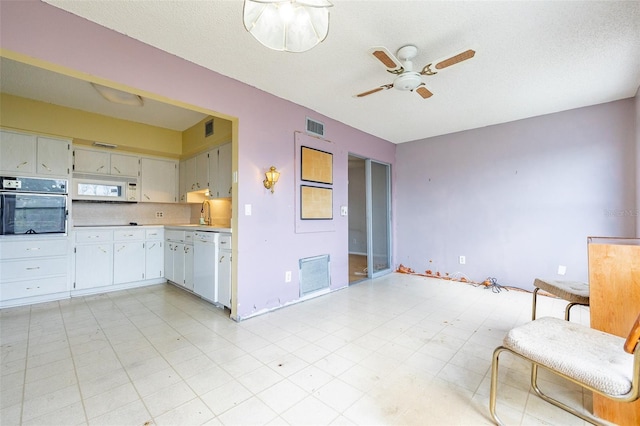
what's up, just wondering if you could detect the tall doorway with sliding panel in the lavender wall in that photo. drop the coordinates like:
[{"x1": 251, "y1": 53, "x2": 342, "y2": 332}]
[{"x1": 348, "y1": 155, "x2": 391, "y2": 284}]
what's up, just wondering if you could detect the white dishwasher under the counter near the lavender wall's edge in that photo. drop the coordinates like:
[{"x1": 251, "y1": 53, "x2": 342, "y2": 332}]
[{"x1": 193, "y1": 231, "x2": 220, "y2": 303}]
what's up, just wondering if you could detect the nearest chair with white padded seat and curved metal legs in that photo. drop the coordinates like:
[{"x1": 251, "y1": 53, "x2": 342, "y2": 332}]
[{"x1": 489, "y1": 315, "x2": 640, "y2": 425}]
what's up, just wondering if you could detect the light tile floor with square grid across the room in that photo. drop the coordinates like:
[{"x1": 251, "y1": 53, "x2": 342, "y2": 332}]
[{"x1": 0, "y1": 274, "x2": 591, "y2": 426}]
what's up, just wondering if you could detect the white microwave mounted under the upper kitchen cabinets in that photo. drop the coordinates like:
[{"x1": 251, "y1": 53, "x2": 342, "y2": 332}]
[{"x1": 70, "y1": 177, "x2": 140, "y2": 203}]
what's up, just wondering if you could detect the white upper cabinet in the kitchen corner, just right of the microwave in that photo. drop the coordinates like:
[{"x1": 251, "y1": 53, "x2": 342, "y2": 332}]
[{"x1": 140, "y1": 157, "x2": 178, "y2": 203}]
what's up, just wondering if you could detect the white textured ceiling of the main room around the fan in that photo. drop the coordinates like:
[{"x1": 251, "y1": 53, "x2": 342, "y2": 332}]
[{"x1": 30, "y1": 0, "x2": 640, "y2": 143}]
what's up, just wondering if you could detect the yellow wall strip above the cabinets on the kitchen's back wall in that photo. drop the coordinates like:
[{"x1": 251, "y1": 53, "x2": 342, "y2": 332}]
[{"x1": 0, "y1": 93, "x2": 182, "y2": 158}]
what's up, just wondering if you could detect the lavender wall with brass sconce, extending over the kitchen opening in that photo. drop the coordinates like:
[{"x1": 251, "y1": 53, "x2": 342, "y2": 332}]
[{"x1": 0, "y1": 2, "x2": 396, "y2": 318}]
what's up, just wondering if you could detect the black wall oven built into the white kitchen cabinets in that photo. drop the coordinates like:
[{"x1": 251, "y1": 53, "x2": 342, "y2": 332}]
[{"x1": 0, "y1": 176, "x2": 68, "y2": 235}]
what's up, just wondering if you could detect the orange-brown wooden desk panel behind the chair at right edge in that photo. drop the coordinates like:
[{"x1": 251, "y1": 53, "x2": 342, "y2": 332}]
[{"x1": 587, "y1": 237, "x2": 640, "y2": 425}]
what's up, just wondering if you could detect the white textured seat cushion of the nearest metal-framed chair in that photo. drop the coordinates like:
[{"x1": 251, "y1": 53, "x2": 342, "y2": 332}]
[{"x1": 504, "y1": 317, "x2": 633, "y2": 396}]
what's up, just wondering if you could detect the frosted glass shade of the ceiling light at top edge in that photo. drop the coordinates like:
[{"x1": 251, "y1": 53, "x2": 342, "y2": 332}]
[{"x1": 244, "y1": 0, "x2": 333, "y2": 52}]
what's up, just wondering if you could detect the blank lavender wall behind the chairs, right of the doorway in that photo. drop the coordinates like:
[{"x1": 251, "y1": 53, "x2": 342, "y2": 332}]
[{"x1": 396, "y1": 99, "x2": 638, "y2": 288}]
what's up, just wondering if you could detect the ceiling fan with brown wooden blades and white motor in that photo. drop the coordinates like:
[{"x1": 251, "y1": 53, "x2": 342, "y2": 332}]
[{"x1": 355, "y1": 45, "x2": 476, "y2": 99}]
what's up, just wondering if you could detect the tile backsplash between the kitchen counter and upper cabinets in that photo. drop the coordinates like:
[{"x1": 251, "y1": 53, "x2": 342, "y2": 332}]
[{"x1": 71, "y1": 200, "x2": 231, "y2": 227}]
